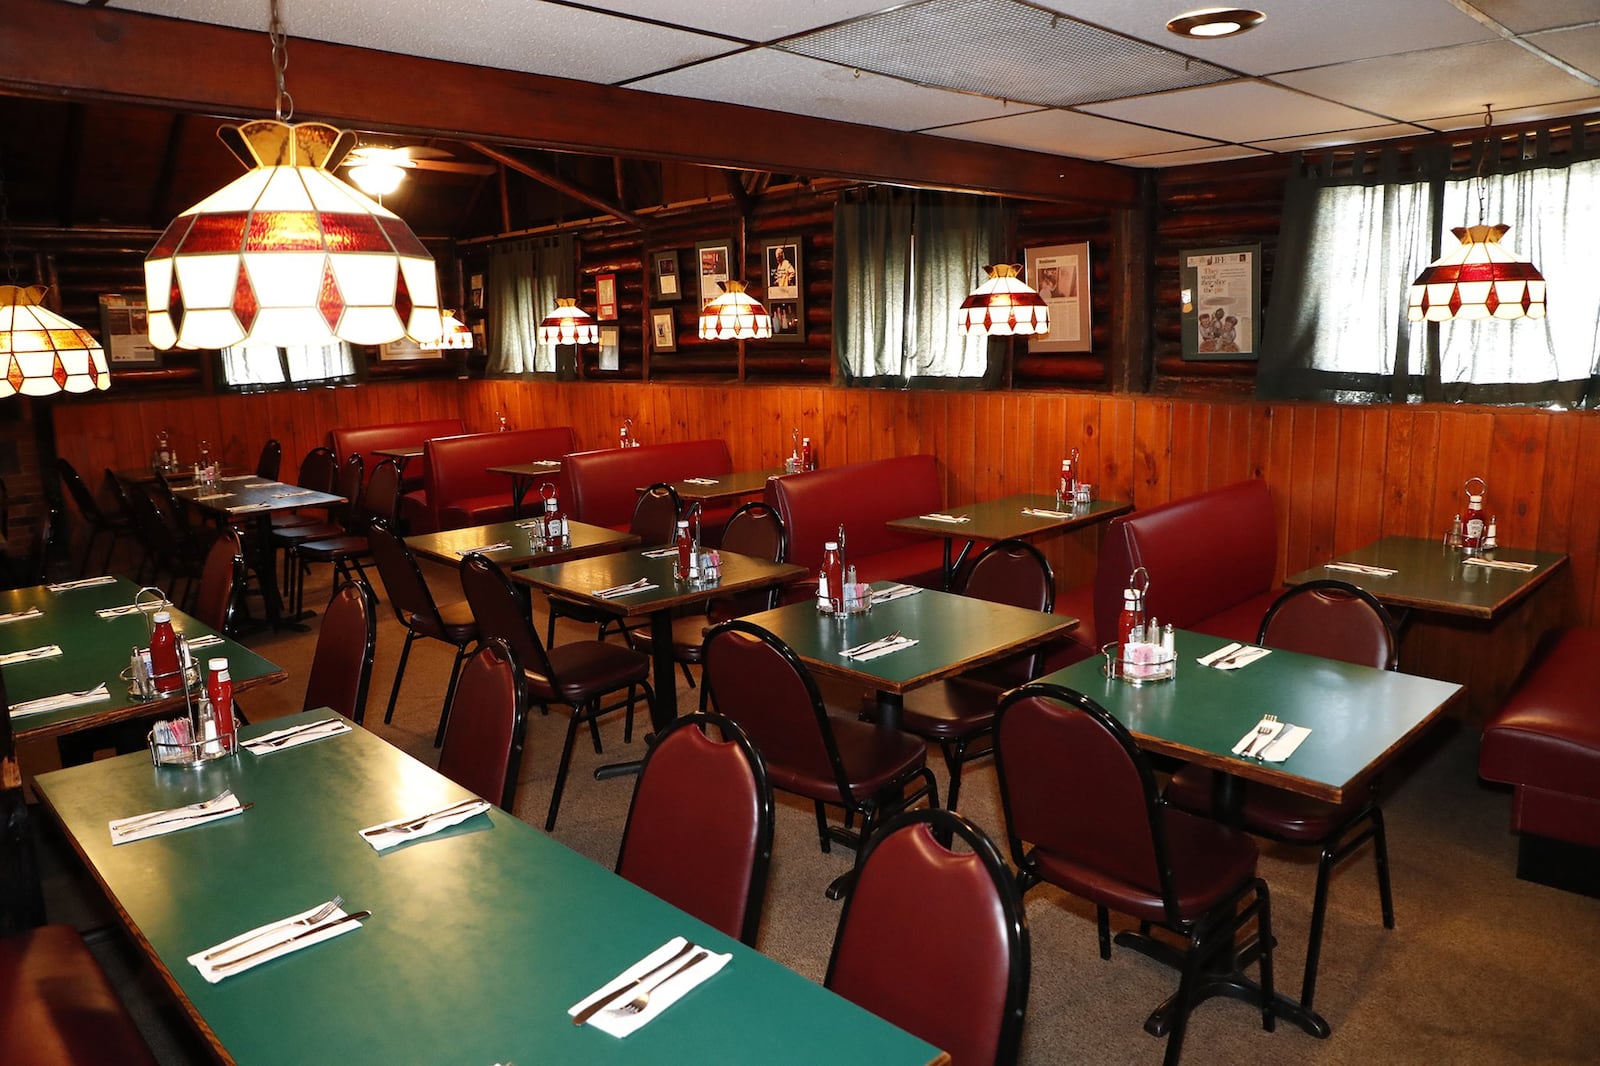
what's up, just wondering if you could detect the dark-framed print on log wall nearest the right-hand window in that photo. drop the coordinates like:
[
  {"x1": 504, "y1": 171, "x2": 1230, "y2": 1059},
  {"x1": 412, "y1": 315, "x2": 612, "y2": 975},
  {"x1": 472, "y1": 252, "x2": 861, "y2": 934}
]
[{"x1": 1178, "y1": 245, "x2": 1261, "y2": 360}]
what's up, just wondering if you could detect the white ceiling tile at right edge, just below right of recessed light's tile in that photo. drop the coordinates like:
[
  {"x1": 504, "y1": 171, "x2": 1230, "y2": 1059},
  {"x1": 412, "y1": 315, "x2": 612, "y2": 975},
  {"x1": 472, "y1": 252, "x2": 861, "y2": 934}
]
[{"x1": 1274, "y1": 40, "x2": 1594, "y2": 122}]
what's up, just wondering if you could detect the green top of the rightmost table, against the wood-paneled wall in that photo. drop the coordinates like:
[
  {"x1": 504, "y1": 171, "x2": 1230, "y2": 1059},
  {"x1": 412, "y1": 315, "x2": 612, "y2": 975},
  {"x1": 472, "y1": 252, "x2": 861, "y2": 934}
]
[{"x1": 1283, "y1": 536, "x2": 1566, "y2": 618}]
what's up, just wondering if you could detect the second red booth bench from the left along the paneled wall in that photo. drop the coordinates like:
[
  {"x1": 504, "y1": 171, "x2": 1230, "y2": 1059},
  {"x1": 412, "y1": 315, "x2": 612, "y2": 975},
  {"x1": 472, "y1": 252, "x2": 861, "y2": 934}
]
[{"x1": 400, "y1": 426, "x2": 578, "y2": 533}]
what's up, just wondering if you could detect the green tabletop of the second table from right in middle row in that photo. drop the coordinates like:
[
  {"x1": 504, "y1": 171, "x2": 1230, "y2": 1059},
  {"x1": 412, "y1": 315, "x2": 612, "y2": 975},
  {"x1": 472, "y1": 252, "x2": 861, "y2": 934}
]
[{"x1": 744, "y1": 581, "x2": 1078, "y2": 693}]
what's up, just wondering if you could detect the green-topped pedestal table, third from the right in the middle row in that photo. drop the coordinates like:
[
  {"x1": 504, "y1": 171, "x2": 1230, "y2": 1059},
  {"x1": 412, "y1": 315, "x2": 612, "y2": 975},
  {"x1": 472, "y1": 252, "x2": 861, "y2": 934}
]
[{"x1": 510, "y1": 547, "x2": 806, "y2": 730}]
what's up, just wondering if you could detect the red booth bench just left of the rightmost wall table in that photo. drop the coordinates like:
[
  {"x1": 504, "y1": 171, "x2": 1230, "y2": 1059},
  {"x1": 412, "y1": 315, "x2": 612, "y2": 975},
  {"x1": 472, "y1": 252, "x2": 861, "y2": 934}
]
[{"x1": 1056, "y1": 480, "x2": 1282, "y2": 650}]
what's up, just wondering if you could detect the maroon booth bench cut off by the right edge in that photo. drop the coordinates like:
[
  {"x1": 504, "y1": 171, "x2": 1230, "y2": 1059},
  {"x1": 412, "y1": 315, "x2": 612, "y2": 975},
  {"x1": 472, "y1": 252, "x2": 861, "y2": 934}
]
[{"x1": 1478, "y1": 629, "x2": 1600, "y2": 895}]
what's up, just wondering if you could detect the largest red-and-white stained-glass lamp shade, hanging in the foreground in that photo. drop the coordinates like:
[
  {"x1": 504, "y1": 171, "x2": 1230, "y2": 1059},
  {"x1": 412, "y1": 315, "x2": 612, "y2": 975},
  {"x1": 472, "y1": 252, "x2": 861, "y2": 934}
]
[{"x1": 144, "y1": 120, "x2": 442, "y2": 349}]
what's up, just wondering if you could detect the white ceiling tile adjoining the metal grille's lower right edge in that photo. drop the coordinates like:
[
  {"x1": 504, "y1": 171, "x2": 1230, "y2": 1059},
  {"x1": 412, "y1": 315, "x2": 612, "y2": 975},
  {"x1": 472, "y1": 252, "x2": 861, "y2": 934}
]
[{"x1": 1082, "y1": 82, "x2": 1395, "y2": 141}]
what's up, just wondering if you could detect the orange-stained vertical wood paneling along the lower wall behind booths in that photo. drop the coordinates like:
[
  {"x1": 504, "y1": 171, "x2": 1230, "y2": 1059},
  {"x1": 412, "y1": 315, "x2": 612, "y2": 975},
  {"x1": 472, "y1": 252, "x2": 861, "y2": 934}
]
[{"x1": 54, "y1": 381, "x2": 1600, "y2": 623}]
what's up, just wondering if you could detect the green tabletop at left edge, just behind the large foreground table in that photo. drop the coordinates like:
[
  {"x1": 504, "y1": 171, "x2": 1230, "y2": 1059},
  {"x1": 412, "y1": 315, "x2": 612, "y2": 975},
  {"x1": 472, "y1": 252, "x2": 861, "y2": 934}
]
[{"x1": 0, "y1": 578, "x2": 288, "y2": 738}]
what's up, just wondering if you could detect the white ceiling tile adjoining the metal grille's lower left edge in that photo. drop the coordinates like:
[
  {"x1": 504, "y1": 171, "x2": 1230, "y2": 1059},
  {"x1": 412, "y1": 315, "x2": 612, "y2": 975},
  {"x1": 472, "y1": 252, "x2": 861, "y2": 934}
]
[{"x1": 629, "y1": 48, "x2": 1021, "y2": 130}]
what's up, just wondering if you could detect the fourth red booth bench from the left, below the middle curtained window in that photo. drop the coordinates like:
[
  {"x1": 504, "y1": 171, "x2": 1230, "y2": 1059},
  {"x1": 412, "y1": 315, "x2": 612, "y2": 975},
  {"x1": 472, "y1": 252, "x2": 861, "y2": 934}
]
[{"x1": 766, "y1": 455, "x2": 944, "y2": 589}]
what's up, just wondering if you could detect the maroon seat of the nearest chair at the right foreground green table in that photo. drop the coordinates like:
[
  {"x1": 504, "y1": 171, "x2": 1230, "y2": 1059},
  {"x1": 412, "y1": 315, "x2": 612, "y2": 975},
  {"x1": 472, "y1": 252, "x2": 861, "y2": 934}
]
[{"x1": 1032, "y1": 808, "x2": 1256, "y2": 924}]
